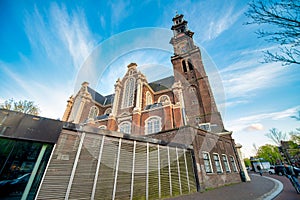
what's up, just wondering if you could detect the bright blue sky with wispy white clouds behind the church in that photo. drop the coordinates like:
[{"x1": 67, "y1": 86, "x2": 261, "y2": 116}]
[{"x1": 0, "y1": 0, "x2": 300, "y2": 156}]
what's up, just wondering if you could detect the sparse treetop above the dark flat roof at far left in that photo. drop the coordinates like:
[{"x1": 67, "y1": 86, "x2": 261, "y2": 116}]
[{"x1": 0, "y1": 99, "x2": 40, "y2": 115}]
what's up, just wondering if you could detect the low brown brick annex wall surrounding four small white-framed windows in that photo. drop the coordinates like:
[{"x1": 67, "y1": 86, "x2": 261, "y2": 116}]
[{"x1": 148, "y1": 126, "x2": 241, "y2": 190}]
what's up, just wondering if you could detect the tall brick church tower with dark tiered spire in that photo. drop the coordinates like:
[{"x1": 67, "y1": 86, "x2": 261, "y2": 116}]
[{"x1": 170, "y1": 14, "x2": 224, "y2": 132}]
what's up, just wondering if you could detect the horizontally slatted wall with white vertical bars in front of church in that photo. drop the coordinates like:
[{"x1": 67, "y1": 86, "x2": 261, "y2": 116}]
[{"x1": 37, "y1": 131, "x2": 197, "y2": 199}]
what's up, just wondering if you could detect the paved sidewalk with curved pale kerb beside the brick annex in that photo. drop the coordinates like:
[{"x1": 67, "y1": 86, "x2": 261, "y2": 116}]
[{"x1": 171, "y1": 174, "x2": 283, "y2": 200}]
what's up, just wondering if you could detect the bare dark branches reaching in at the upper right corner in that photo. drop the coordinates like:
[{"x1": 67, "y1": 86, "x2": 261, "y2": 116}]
[{"x1": 245, "y1": 0, "x2": 300, "y2": 65}]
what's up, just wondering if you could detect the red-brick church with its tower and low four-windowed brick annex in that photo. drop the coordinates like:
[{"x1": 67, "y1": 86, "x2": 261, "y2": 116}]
[{"x1": 64, "y1": 15, "x2": 245, "y2": 189}]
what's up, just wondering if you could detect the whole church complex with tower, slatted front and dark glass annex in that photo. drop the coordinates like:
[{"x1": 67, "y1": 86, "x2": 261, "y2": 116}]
[{"x1": 0, "y1": 15, "x2": 247, "y2": 199}]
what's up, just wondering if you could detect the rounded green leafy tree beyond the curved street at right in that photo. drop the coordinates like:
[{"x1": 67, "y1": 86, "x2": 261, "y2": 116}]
[{"x1": 256, "y1": 144, "x2": 282, "y2": 164}]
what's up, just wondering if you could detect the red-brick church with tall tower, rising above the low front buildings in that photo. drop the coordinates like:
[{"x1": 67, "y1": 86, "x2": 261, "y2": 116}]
[{"x1": 63, "y1": 15, "x2": 224, "y2": 135}]
